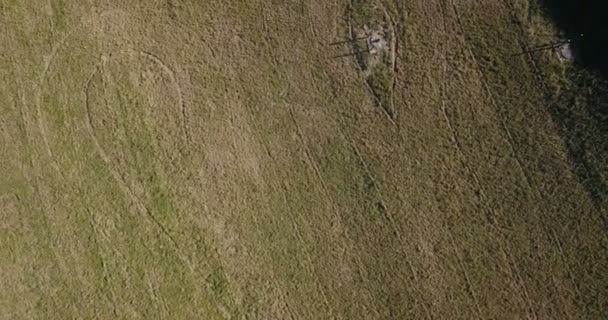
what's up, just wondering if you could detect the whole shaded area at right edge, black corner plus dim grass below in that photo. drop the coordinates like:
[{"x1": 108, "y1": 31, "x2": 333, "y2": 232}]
[{"x1": 541, "y1": 0, "x2": 608, "y2": 212}]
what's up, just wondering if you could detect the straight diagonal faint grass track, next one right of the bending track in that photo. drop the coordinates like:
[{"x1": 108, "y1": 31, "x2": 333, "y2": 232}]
[{"x1": 450, "y1": 0, "x2": 582, "y2": 308}]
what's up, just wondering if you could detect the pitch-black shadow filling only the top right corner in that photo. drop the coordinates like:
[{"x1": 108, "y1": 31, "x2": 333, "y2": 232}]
[{"x1": 542, "y1": 0, "x2": 608, "y2": 79}]
